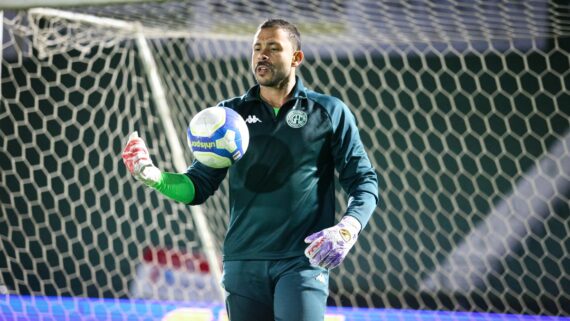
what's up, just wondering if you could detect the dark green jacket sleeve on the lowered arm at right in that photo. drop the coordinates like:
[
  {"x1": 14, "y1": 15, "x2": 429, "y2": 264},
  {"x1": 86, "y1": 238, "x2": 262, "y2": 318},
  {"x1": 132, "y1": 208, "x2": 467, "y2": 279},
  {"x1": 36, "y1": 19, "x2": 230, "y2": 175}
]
[{"x1": 331, "y1": 100, "x2": 378, "y2": 228}]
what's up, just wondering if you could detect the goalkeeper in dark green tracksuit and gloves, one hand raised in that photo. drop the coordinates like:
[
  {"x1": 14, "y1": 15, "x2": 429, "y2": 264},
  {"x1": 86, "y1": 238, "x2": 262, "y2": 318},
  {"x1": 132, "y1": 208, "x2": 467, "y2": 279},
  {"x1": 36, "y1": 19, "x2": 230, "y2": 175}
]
[{"x1": 123, "y1": 19, "x2": 378, "y2": 321}]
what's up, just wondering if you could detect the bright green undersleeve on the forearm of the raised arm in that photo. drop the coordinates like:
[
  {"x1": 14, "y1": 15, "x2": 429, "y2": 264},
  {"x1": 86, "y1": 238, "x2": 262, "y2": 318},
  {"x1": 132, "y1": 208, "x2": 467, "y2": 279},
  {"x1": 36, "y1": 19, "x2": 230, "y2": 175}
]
[{"x1": 152, "y1": 173, "x2": 195, "y2": 204}]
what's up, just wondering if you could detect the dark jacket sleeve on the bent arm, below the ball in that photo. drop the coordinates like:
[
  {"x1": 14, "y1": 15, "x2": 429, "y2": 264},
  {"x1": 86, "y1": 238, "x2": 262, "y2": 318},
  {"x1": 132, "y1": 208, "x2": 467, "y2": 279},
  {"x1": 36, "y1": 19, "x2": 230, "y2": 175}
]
[{"x1": 186, "y1": 161, "x2": 228, "y2": 205}]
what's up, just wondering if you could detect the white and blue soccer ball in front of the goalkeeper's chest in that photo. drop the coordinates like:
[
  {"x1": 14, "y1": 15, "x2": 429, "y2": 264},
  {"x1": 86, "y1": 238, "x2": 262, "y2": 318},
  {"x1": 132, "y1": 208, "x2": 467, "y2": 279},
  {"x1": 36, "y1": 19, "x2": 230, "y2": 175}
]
[{"x1": 187, "y1": 107, "x2": 249, "y2": 168}]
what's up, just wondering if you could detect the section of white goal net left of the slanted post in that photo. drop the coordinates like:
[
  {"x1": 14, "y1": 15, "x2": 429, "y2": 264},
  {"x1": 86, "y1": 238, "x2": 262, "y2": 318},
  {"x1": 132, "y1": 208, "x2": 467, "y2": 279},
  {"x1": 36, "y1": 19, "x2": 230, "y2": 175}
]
[{"x1": 0, "y1": 8, "x2": 220, "y2": 300}]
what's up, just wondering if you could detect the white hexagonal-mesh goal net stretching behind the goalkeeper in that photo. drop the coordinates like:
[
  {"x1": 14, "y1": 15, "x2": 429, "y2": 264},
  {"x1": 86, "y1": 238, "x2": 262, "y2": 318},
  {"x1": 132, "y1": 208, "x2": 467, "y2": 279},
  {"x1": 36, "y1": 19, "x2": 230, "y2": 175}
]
[{"x1": 0, "y1": 0, "x2": 570, "y2": 315}]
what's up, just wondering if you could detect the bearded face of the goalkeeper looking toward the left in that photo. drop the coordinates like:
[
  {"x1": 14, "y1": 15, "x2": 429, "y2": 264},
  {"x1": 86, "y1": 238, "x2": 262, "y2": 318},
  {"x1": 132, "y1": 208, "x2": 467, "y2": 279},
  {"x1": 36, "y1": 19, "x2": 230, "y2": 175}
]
[{"x1": 251, "y1": 28, "x2": 297, "y2": 88}]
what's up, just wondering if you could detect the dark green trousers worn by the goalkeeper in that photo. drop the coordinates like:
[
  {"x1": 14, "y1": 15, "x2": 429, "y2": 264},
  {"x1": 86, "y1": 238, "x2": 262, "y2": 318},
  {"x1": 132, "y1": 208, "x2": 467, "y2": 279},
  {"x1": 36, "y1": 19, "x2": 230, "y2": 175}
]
[{"x1": 222, "y1": 256, "x2": 329, "y2": 321}]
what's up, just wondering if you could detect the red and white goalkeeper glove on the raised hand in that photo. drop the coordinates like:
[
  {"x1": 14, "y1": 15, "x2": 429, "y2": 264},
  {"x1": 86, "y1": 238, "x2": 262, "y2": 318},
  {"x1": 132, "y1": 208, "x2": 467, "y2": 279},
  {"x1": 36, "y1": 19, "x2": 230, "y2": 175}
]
[{"x1": 122, "y1": 131, "x2": 161, "y2": 186}]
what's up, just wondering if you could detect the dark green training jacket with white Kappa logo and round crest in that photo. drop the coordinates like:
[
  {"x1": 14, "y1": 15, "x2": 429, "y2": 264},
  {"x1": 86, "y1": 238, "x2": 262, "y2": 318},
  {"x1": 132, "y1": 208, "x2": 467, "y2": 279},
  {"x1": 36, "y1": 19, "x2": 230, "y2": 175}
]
[{"x1": 186, "y1": 78, "x2": 378, "y2": 260}]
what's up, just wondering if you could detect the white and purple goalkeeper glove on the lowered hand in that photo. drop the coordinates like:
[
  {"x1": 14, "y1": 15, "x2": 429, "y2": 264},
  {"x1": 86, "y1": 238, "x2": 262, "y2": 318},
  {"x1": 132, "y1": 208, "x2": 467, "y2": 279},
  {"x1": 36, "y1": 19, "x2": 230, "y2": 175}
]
[{"x1": 305, "y1": 216, "x2": 362, "y2": 269}]
